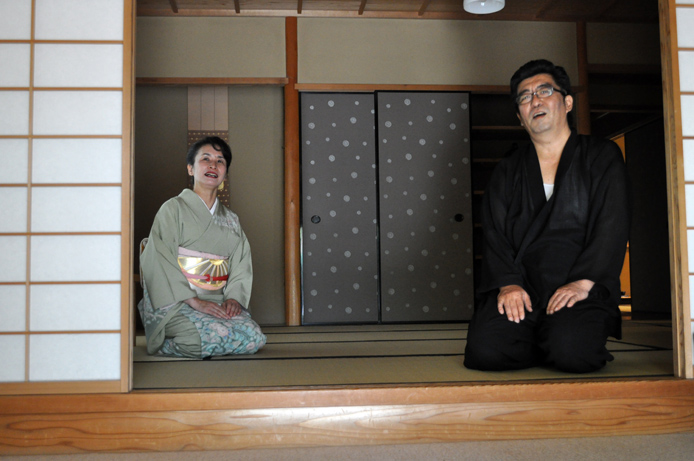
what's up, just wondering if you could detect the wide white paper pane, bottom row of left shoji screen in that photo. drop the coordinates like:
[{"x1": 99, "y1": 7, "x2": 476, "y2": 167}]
[{"x1": 29, "y1": 333, "x2": 120, "y2": 381}]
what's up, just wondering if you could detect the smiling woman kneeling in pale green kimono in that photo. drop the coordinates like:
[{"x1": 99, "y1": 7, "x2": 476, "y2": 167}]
[{"x1": 138, "y1": 136, "x2": 265, "y2": 358}]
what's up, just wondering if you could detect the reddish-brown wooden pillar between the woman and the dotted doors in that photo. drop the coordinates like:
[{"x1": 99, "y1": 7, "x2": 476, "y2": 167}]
[{"x1": 284, "y1": 17, "x2": 301, "y2": 326}]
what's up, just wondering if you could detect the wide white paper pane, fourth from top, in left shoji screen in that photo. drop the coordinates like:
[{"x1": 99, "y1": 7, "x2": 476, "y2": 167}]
[{"x1": 32, "y1": 139, "x2": 123, "y2": 184}]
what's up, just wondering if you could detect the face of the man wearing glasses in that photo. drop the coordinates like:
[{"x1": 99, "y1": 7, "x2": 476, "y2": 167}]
[{"x1": 518, "y1": 74, "x2": 573, "y2": 137}]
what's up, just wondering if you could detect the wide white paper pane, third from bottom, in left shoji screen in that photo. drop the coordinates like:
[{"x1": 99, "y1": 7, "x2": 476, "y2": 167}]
[{"x1": 31, "y1": 235, "x2": 121, "y2": 282}]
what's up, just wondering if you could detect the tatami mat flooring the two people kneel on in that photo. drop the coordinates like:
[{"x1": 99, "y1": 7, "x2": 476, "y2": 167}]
[{"x1": 133, "y1": 321, "x2": 673, "y2": 389}]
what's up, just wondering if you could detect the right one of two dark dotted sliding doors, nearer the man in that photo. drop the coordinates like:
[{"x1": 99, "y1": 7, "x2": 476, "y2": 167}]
[{"x1": 377, "y1": 93, "x2": 473, "y2": 322}]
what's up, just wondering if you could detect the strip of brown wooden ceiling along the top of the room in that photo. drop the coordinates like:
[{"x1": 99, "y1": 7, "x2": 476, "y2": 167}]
[{"x1": 137, "y1": 0, "x2": 658, "y2": 23}]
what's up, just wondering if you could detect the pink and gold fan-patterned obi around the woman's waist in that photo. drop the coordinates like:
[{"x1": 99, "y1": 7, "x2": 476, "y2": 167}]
[{"x1": 178, "y1": 248, "x2": 229, "y2": 291}]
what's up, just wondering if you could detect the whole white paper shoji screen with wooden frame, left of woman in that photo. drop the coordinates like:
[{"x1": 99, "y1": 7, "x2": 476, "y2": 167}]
[{"x1": 0, "y1": 0, "x2": 132, "y2": 393}]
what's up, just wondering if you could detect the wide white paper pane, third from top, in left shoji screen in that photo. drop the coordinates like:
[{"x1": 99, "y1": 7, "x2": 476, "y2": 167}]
[{"x1": 34, "y1": 91, "x2": 123, "y2": 135}]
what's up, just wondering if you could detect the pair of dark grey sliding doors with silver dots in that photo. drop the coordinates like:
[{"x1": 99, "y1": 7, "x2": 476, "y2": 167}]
[{"x1": 301, "y1": 92, "x2": 473, "y2": 324}]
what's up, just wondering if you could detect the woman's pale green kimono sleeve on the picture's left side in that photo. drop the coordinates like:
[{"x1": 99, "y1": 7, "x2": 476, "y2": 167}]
[{"x1": 140, "y1": 199, "x2": 197, "y2": 309}]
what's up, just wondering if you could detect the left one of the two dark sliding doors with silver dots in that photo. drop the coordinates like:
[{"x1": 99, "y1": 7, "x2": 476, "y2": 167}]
[{"x1": 301, "y1": 93, "x2": 379, "y2": 324}]
